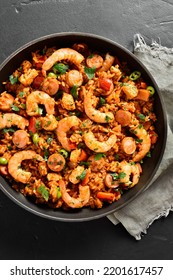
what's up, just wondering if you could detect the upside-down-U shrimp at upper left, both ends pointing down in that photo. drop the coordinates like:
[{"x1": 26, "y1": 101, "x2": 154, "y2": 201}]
[{"x1": 26, "y1": 90, "x2": 55, "y2": 116}]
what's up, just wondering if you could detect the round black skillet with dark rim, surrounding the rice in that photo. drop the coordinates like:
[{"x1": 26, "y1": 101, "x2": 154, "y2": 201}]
[{"x1": 0, "y1": 33, "x2": 167, "y2": 222}]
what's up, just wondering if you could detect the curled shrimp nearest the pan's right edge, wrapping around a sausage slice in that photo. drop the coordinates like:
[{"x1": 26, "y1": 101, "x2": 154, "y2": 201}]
[{"x1": 131, "y1": 126, "x2": 151, "y2": 162}]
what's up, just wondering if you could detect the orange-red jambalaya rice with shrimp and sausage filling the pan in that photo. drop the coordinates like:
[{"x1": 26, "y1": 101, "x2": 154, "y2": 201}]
[{"x1": 0, "y1": 43, "x2": 158, "y2": 209}]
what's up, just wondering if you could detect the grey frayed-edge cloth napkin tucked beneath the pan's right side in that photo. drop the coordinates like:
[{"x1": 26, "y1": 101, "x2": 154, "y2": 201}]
[{"x1": 108, "y1": 34, "x2": 173, "y2": 240}]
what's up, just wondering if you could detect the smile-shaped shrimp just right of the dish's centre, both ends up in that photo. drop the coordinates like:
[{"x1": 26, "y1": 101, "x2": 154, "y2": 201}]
[{"x1": 84, "y1": 131, "x2": 117, "y2": 153}]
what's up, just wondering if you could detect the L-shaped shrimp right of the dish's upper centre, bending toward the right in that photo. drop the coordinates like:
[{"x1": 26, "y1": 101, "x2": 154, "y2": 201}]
[{"x1": 84, "y1": 90, "x2": 114, "y2": 123}]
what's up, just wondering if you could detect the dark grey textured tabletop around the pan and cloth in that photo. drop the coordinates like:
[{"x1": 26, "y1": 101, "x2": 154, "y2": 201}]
[{"x1": 0, "y1": 0, "x2": 173, "y2": 259}]
